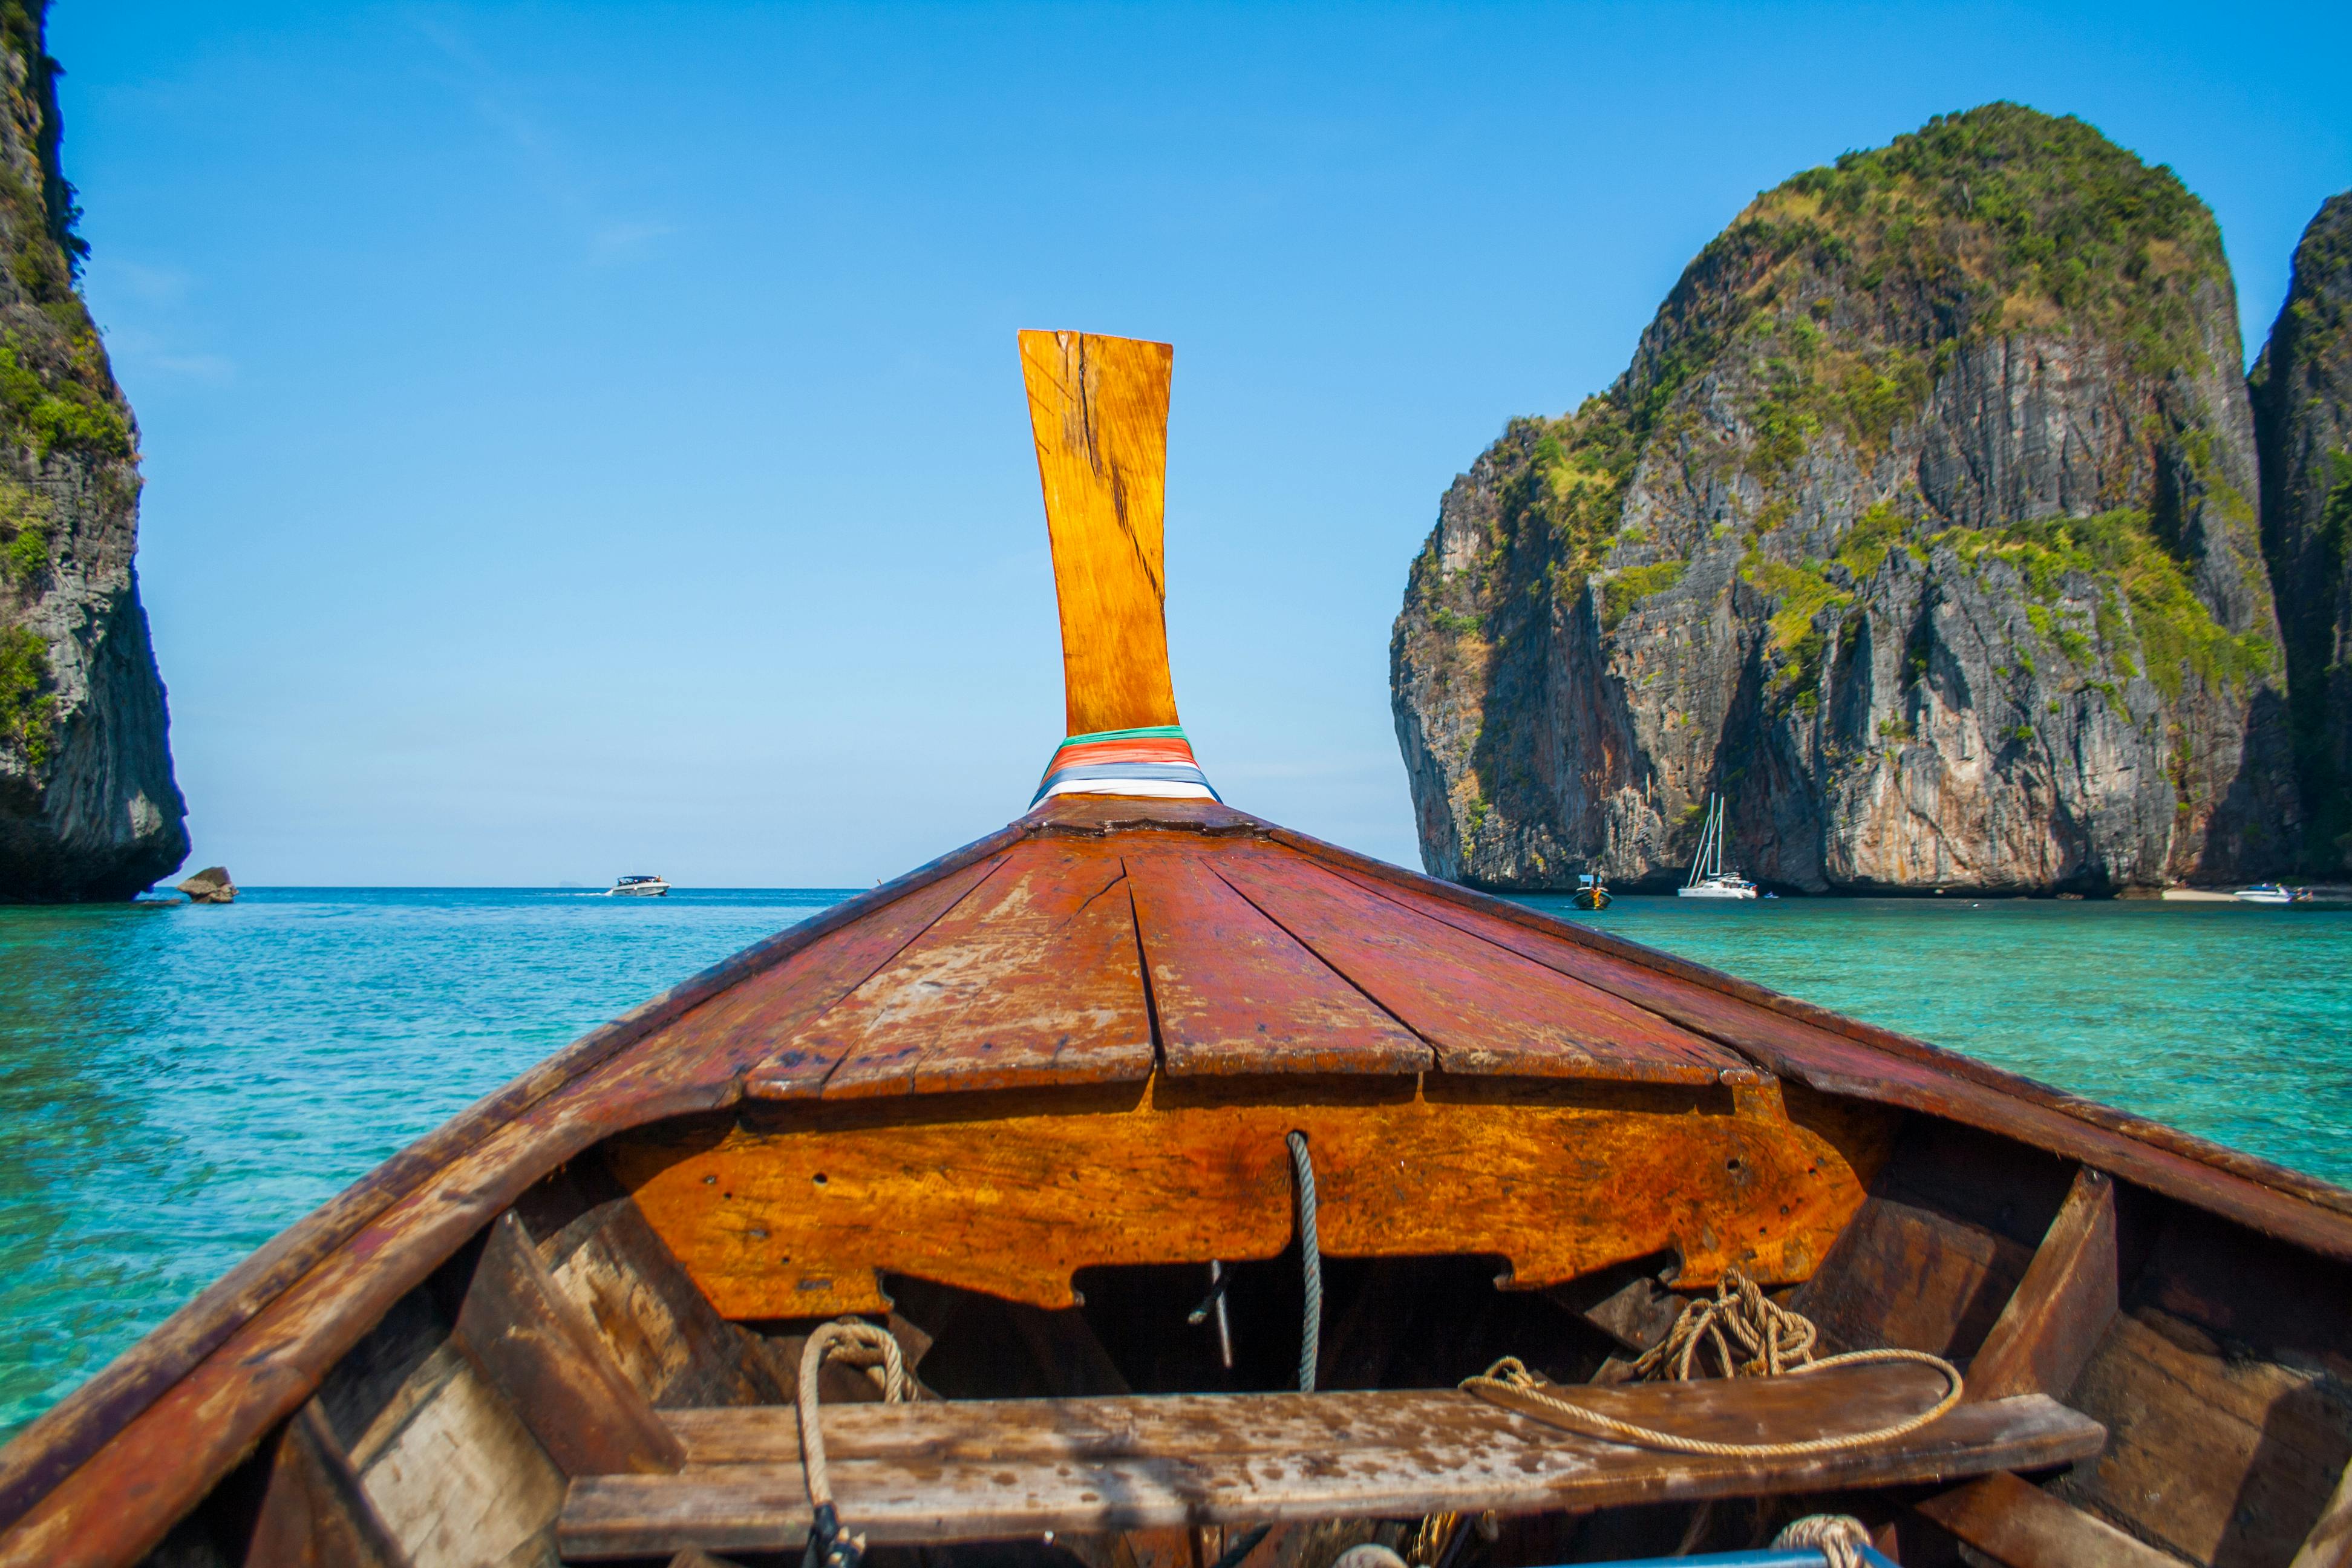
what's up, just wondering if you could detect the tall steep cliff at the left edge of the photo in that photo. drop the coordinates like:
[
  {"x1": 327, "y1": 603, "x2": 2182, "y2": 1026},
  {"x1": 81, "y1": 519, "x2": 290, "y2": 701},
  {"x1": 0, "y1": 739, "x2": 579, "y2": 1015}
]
[{"x1": 0, "y1": 5, "x2": 188, "y2": 903}]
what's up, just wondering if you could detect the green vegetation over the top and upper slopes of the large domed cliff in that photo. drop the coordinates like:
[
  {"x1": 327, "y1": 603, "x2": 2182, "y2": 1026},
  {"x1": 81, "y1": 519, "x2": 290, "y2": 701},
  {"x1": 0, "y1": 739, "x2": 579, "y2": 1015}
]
[{"x1": 1420, "y1": 103, "x2": 2246, "y2": 662}]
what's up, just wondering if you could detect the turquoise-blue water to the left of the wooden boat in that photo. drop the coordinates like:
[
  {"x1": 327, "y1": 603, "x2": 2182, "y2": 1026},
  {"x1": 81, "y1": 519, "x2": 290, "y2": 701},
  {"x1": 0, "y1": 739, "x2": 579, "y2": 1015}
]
[{"x1": 0, "y1": 889, "x2": 849, "y2": 1436}]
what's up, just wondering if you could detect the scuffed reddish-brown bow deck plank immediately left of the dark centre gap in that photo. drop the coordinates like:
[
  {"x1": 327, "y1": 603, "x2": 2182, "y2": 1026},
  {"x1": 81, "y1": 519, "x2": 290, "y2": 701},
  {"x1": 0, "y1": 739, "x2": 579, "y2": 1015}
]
[{"x1": 818, "y1": 839, "x2": 1152, "y2": 1100}]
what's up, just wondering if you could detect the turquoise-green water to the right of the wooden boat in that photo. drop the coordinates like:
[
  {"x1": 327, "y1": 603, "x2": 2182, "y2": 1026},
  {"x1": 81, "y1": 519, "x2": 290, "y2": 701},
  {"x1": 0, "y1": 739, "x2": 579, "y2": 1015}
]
[{"x1": 1520, "y1": 896, "x2": 2352, "y2": 1183}]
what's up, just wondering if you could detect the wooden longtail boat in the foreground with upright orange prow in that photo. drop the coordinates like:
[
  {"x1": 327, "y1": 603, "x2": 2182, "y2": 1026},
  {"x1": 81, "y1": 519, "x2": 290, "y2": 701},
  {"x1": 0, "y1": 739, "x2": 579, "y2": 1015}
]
[{"x1": 0, "y1": 334, "x2": 2352, "y2": 1568}]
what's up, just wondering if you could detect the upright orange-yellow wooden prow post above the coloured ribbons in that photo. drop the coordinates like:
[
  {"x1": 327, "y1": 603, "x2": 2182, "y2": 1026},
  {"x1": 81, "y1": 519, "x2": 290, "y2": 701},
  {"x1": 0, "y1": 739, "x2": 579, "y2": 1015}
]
[{"x1": 1021, "y1": 332, "x2": 1176, "y2": 736}]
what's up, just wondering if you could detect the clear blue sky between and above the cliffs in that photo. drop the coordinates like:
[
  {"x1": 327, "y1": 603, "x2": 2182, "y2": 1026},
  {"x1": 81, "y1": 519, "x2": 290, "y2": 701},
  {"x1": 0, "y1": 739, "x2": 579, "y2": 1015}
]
[{"x1": 50, "y1": 0, "x2": 2352, "y2": 886}]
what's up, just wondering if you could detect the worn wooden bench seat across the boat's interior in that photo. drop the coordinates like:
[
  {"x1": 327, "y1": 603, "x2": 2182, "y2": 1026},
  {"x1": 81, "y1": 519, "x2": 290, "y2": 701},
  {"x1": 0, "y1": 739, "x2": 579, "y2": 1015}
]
[{"x1": 557, "y1": 1364, "x2": 2105, "y2": 1558}]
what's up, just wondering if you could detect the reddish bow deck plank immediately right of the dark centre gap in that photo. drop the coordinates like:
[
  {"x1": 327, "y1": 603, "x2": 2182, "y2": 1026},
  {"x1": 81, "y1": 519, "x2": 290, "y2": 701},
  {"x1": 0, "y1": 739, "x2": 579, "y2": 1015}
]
[{"x1": 1126, "y1": 849, "x2": 1435, "y2": 1077}]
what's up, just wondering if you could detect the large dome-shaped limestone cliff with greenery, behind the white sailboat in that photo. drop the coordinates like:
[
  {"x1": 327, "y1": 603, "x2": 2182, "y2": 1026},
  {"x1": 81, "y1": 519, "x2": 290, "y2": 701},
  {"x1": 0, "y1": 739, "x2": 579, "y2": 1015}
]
[{"x1": 1390, "y1": 103, "x2": 2300, "y2": 893}]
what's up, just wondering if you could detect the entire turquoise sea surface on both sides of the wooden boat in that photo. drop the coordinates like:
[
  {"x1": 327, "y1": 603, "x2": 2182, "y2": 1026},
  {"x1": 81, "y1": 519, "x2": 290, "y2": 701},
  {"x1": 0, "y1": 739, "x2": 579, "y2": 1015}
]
[{"x1": 0, "y1": 889, "x2": 2352, "y2": 1436}]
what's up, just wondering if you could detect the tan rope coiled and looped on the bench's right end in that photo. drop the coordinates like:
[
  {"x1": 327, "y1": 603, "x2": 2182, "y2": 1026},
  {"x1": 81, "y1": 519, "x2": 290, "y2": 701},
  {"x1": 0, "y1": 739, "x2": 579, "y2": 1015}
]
[{"x1": 1460, "y1": 1269, "x2": 1966, "y2": 1457}]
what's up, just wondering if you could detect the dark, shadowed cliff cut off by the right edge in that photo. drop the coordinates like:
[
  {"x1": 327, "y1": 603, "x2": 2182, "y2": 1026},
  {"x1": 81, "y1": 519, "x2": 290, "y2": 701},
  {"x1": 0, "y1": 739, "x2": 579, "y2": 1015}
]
[{"x1": 2251, "y1": 191, "x2": 2352, "y2": 875}]
